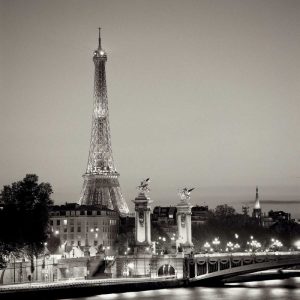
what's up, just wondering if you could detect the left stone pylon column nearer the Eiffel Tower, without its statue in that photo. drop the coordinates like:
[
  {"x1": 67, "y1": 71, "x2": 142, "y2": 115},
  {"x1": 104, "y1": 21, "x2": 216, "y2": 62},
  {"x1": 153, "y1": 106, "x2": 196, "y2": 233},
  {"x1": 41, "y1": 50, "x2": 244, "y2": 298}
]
[{"x1": 133, "y1": 192, "x2": 152, "y2": 253}]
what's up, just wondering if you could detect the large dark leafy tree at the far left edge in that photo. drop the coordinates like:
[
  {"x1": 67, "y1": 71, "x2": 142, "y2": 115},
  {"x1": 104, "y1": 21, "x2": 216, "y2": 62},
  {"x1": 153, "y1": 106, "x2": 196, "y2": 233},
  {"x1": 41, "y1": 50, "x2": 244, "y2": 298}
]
[{"x1": 0, "y1": 174, "x2": 53, "y2": 268}]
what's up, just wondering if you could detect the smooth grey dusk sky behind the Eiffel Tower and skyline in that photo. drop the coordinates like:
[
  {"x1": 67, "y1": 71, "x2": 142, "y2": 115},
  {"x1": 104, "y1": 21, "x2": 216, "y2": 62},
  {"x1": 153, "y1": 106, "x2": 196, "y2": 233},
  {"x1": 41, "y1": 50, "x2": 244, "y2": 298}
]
[{"x1": 0, "y1": 0, "x2": 300, "y2": 217}]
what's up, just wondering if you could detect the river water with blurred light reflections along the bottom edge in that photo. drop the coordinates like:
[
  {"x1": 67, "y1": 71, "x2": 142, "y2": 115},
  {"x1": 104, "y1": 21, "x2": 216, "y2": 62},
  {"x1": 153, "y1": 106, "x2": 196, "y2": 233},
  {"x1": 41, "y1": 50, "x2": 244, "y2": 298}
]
[{"x1": 64, "y1": 277, "x2": 300, "y2": 300}]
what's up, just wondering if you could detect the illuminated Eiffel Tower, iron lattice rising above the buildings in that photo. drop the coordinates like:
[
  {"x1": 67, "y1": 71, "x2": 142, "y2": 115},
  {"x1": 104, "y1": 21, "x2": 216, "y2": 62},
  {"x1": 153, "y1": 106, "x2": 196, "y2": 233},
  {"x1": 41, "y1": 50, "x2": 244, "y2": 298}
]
[{"x1": 79, "y1": 28, "x2": 129, "y2": 215}]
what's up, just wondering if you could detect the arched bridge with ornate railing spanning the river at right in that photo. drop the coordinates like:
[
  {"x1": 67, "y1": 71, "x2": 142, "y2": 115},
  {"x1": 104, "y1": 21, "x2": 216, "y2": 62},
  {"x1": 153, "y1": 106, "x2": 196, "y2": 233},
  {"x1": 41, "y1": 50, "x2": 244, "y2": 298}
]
[{"x1": 186, "y1": 252, "x2": 300, "y2": 285}]
